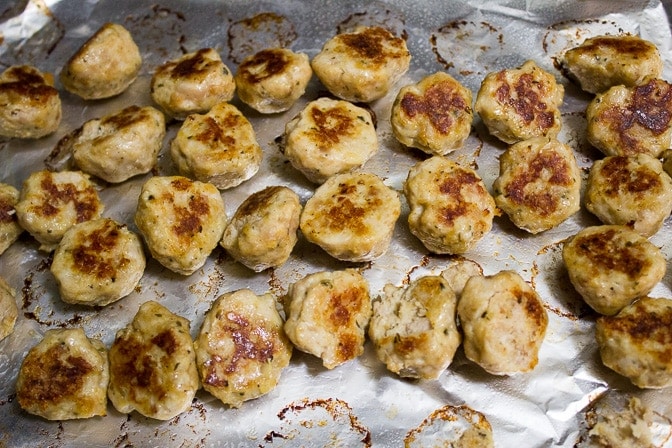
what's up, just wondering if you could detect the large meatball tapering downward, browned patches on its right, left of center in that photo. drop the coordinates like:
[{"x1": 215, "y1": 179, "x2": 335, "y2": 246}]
[{"x1": 135, "y1": 176, "x2": 227, "y2": 275}]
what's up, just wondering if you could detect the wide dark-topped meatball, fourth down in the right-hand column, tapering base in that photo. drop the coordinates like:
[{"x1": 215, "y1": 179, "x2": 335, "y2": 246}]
[{"x1": 562, "y1": 225, "x2": 667, "y2": 316}]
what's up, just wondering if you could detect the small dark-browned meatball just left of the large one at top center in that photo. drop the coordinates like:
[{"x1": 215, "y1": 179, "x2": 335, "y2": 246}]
[{"x1": 235, "y1": 48, "x2": 313, "y2": 114}]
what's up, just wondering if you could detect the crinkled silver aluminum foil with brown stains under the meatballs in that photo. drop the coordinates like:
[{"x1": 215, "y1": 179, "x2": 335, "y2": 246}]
[{"x1": 0, "y1": 0, "x2": 672, "y2": 447}]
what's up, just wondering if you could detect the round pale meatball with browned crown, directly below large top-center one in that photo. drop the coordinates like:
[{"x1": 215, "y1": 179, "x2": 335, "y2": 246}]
[{"x1": 284, "y1": 98, "x2": 378, "y2": 184}]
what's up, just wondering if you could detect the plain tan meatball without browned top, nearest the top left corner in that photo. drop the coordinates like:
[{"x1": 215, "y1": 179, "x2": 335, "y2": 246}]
[{"x1": 60, "y1": 23, "x2": 142, "y2": 100}]
